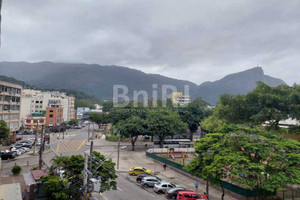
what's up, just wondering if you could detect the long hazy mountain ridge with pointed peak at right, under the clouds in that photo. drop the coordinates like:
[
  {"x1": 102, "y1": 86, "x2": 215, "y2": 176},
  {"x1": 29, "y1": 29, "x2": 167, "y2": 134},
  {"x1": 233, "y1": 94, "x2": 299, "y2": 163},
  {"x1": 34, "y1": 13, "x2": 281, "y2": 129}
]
[{"x1": 0, "y1": 62, "x2": 284, "y2": 104}]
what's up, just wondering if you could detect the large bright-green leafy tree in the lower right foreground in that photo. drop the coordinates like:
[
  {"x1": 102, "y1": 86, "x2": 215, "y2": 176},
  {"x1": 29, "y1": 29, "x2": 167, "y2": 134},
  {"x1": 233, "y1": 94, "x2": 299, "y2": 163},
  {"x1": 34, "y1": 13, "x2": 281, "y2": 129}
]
[{"x1": 187, "y1": 129, "x2": 300, "y2": 199}]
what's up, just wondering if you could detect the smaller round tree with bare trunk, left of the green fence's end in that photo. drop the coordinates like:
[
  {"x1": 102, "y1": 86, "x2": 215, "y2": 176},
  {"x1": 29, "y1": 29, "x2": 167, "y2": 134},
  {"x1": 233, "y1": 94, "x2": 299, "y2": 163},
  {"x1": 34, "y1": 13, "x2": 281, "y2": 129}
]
[{"x1": 117, "y1": 116, "x2": 146, "y2": 151}]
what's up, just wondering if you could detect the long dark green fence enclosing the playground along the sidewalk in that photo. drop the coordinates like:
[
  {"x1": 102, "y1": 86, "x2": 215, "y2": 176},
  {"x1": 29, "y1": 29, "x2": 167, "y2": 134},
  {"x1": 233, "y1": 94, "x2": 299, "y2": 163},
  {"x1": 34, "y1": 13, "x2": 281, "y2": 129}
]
[{"x1": 146, "y1": 151, "x2": 276, "y2": 197}]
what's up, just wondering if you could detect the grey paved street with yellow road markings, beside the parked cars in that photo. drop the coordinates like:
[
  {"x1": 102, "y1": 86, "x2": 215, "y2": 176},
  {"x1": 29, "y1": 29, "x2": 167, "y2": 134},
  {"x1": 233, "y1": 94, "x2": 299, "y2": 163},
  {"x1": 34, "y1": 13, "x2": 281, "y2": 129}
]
[{"x1": 2, "y1": 128, "x2": 236, "y2": 200}]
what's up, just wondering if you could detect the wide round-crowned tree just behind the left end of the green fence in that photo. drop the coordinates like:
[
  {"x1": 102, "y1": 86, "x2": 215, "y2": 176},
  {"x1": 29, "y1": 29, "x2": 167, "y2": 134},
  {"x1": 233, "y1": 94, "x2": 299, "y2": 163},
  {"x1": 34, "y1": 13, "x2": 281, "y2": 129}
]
[{"x1": 146, "y1": 109, "x2": 187, "y2": 148}]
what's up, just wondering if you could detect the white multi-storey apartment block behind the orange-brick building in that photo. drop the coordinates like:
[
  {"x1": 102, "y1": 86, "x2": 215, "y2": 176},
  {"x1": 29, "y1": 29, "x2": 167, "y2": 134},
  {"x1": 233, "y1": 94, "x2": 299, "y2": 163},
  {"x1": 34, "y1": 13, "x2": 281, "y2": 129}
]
[{"x1": 21, "y1": 89, "x2": 75, "y2": 121}]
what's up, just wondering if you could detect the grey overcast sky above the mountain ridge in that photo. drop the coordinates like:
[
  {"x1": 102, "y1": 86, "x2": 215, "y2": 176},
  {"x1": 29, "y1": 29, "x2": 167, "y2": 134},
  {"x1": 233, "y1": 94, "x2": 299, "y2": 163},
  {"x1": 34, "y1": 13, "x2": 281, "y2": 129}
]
[{"x1": 0, "y1": 0, "x2": 300, "y2": 84}]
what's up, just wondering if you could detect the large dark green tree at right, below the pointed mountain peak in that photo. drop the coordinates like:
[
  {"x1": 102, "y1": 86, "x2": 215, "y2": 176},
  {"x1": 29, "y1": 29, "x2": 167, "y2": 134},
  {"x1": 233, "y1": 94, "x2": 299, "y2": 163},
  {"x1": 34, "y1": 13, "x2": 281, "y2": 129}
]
[{"x1": 215, "y1": 82, "x2": 292, "y2": 130}]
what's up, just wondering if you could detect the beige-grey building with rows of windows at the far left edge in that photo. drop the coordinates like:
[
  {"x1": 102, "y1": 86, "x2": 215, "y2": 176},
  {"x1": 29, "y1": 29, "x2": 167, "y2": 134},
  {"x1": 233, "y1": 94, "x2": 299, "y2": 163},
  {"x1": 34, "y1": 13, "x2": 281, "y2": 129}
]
[{"x1": 0, "y1": 81, "x2": 22, "y2": 136}]
